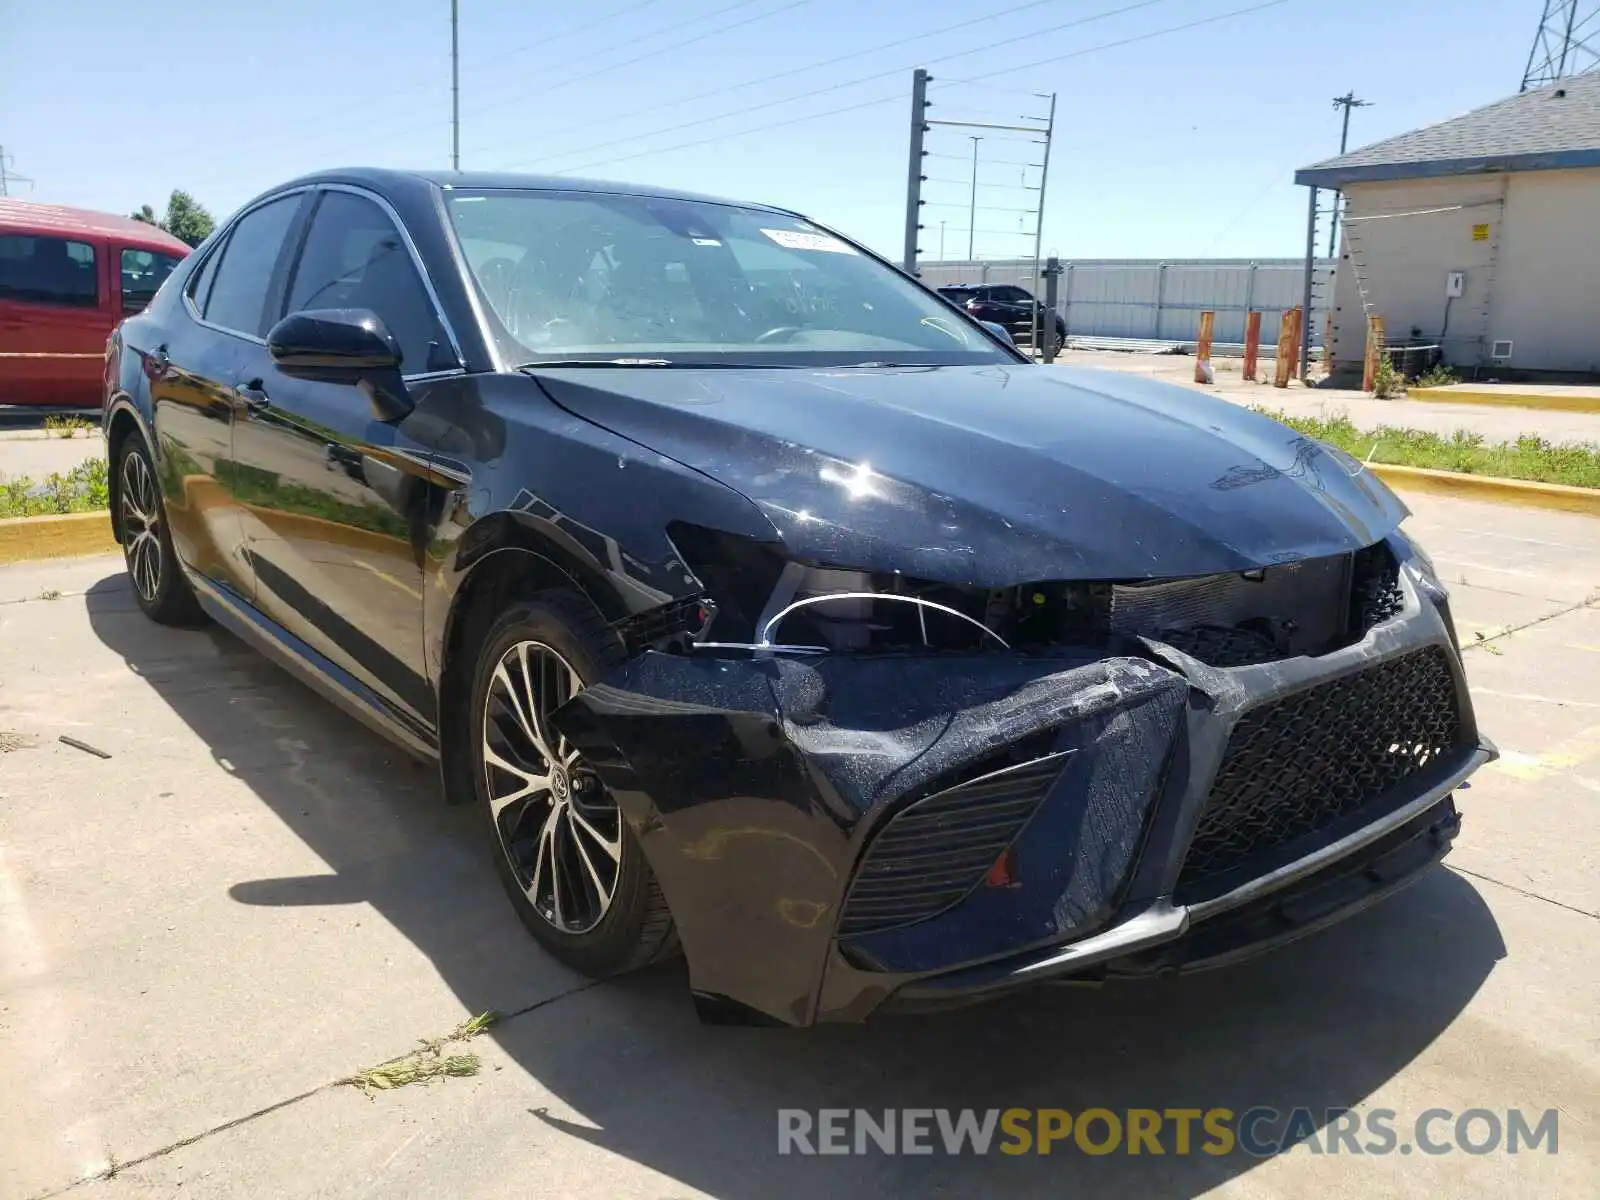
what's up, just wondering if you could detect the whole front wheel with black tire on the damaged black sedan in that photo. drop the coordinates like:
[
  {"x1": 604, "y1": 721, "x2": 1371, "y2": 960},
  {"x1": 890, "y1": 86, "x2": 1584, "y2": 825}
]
[{"x1": 467, "y1": 589, "x2": 677, "y2": 978}]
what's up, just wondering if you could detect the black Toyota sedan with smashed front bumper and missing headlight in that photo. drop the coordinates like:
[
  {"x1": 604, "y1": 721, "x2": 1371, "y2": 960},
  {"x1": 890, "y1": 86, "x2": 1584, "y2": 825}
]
[{"x1": 106, "y1": 170, "x2": 1493, "y2": 1024}]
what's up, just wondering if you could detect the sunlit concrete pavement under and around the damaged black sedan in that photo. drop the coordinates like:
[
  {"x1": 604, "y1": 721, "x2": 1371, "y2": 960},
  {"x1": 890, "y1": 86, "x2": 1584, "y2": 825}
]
[{"x1": 0, "y1": 498, "x2": 1600, "y2": 1200}]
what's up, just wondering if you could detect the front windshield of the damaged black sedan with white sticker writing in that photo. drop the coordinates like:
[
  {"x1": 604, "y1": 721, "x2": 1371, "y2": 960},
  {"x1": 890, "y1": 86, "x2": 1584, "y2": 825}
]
[{"x1": 445, "y1": 189, "x2": 1014, "y2": 366}]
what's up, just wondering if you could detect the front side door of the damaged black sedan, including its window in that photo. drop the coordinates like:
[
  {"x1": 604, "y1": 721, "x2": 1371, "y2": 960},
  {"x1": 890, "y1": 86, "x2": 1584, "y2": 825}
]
[{"x1": 234, "y1": 187, "x2": 459, "y2": 731}]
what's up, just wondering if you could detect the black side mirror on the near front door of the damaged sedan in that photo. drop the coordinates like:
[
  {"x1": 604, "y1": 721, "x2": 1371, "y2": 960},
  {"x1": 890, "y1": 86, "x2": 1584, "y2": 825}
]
[{"x1": 267, "y1": 309, "x2": 414, "y2": 421}]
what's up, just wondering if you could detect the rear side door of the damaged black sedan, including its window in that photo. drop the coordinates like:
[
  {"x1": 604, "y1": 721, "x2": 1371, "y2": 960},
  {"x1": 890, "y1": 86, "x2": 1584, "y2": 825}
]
[{"x1": 148, "y1": 192, "x2": 309, "y2": 600}]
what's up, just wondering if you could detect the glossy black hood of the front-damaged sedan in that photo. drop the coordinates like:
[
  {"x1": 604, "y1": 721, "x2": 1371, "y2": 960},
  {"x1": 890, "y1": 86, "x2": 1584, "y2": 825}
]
[{"x1": 538, "y1": 365, "x2": 1406, "y2": 587}]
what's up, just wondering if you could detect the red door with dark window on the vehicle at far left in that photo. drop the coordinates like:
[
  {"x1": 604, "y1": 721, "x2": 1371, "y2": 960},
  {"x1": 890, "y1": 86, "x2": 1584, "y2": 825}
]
[{"x1": 0, "y1": 232, "x2": 112, "y2": 408}]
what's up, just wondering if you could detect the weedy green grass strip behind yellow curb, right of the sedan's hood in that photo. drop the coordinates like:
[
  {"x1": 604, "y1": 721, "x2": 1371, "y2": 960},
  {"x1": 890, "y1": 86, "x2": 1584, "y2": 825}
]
[{"x1": 1256, "y1": 408, "x2": 1600, "y2": 488}]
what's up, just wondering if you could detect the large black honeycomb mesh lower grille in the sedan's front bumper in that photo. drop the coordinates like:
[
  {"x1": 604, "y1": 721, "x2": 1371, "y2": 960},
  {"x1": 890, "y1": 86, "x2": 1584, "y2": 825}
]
[{"x1": 1178, "y1": 646, "x2": 1461, "y2": 893}]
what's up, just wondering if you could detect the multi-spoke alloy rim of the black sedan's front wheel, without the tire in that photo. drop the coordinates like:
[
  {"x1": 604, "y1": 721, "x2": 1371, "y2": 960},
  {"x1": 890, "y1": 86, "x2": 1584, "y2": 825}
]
[{"x1": 482, "y1": 642, "x2": 622, "y2": 934}]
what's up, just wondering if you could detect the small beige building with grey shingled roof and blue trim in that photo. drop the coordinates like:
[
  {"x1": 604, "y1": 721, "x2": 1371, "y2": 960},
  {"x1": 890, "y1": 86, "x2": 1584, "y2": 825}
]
[{"x1": 1294, "y1": 74, "x2": 1600, "y2": 378}]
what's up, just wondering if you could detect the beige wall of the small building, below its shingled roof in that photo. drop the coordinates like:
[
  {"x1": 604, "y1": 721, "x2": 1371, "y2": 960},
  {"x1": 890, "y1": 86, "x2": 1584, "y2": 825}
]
[{"x1": 1330, "y1": 170, "x2": 1600, "y2": 371}]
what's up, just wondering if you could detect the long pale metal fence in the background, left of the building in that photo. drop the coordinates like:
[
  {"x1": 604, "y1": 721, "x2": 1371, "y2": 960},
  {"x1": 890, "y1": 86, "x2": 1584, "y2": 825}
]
[{"x1": 918, "y1": 258, "x2": 1333, "y2": 352}]
